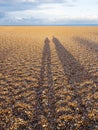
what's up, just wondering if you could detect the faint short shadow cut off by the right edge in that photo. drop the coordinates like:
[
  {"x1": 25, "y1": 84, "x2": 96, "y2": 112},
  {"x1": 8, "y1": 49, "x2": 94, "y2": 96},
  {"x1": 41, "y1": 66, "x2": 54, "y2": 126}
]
[{"x1": 73, "y1": 37, "x2": 98, "y2": 55}]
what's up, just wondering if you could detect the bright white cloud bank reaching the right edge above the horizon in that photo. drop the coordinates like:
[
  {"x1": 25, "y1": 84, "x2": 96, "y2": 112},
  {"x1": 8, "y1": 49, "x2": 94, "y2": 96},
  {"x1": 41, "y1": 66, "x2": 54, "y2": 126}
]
[{"x1": 8, "y1": 4, "x2": 98, "y2": 24}]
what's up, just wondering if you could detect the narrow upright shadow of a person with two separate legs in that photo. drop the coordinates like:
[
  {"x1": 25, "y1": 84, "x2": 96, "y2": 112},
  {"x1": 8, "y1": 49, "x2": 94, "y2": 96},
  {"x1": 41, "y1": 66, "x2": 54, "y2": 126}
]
[{"x1": 33, "y1": 38, "x2": 56, "y2": 130}]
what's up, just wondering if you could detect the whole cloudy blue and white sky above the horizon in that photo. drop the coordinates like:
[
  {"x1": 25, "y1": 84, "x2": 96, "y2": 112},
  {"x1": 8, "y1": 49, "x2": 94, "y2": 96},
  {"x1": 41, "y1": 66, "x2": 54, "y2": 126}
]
[{"x1": 0, "y1": 0, "x2": 98, "y2": 25}]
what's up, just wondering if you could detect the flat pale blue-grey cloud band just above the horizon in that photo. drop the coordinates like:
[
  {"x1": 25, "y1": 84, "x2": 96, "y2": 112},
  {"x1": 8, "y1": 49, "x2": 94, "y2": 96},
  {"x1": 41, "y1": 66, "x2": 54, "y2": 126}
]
[{"x1": 2, "y1": 17, "x2": 98, "y2": 25}]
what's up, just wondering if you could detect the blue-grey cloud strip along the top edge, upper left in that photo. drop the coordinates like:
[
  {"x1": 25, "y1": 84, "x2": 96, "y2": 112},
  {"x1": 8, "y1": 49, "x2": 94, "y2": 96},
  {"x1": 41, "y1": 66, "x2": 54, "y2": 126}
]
[{"x1": 0, "y1": 0, "x2": 75, "y2": 12}]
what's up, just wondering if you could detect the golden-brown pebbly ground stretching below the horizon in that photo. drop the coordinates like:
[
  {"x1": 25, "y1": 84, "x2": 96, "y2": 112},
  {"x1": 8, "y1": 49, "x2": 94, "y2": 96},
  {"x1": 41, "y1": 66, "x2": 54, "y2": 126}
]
[{"x1": 0, "y1": 26, "x2": 98, "y2": 130}]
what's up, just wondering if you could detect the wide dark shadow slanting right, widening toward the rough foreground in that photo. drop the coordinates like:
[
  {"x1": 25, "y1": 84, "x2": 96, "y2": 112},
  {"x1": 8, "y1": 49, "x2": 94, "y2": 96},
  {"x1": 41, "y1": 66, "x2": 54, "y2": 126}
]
[{"x1": 52, "y1": 37, "x2": 90, "y2": 84}]
